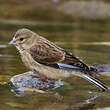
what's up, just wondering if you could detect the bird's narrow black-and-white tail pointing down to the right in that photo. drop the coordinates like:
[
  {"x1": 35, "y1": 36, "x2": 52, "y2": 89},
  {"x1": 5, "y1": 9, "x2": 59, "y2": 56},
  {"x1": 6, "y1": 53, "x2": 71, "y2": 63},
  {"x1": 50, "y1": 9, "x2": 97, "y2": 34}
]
[{"x1": 74, "y1": 73, "x2": 109, "y2": 91}]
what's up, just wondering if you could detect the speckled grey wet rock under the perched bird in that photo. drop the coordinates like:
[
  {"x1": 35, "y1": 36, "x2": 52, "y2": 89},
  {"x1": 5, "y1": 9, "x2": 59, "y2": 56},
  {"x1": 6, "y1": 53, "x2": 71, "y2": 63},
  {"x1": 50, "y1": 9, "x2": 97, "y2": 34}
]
[{"x1": 10, "y1": 71, "x2": 63, "y2": 91}]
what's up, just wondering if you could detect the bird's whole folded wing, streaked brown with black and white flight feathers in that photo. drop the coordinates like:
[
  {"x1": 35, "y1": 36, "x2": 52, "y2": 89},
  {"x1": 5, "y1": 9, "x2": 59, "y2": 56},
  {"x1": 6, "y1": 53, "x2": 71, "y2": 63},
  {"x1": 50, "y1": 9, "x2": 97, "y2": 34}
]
[{"x1": 30, "y1": 39, "x2": 97, "y2": 75}]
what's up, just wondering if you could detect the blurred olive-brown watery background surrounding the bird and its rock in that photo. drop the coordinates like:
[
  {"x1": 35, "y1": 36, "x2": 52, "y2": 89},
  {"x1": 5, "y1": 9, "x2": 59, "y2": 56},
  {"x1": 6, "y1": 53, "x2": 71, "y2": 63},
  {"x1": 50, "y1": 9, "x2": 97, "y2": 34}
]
[{"x1": 0, "y1": 0, "x2": 110, "y2": 110}]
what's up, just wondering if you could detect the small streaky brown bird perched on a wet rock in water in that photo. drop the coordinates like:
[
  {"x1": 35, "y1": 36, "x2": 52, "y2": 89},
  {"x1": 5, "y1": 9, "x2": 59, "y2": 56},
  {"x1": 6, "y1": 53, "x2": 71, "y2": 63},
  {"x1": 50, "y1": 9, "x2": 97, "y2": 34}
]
[{"x1": 9, "y1": 28, "x2": 108, "y2": 91}]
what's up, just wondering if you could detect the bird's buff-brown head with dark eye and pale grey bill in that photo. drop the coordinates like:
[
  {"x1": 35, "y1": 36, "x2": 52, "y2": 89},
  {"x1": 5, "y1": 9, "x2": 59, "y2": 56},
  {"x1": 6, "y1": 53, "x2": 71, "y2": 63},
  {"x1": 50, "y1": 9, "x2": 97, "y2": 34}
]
[{"x1": 9, "y1": 28, "x2": 36, "y2": 51}]
